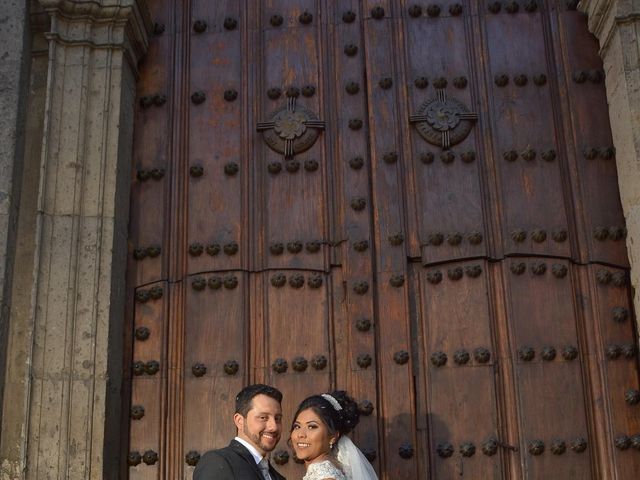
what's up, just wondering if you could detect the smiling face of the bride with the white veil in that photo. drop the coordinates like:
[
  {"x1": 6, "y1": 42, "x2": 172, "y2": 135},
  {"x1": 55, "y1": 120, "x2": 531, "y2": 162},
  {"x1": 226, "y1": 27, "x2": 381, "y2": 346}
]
[{"x1": 291, "y1": 408, "x2": 336, "y2": 464}]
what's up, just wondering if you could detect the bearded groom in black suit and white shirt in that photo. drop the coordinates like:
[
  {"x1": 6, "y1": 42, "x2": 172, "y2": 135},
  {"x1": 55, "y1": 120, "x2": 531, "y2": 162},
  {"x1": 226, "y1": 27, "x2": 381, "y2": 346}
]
[{"x1": 193, "y1": 384, "x2": 286, "y2": 480}]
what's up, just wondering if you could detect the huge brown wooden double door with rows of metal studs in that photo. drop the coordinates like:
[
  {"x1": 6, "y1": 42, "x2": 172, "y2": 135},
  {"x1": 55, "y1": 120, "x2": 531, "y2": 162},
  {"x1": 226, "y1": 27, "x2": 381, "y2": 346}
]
[{"x1": 123, "y1": 0, "x2": 640, "y2": 479}]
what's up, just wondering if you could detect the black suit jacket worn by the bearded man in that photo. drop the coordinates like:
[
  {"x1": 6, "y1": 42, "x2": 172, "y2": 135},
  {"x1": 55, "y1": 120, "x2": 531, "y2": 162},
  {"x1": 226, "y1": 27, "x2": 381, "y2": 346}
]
[{"x1": 193, "y1": 440, "x2": 286, "y2": 480}]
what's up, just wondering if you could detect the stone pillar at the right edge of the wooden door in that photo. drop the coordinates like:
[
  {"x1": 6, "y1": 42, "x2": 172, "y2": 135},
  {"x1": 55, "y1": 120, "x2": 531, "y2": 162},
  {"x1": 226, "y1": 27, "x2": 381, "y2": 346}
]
[{"x1": 578, "y1": 0, "x2": 640, "y2": 326}]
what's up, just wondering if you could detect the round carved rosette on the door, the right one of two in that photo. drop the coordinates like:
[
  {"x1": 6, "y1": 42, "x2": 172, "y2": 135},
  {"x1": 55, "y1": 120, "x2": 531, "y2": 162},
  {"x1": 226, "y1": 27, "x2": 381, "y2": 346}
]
[{"x1": 409, "y1": 90, "x2": 478, "y2": 149}]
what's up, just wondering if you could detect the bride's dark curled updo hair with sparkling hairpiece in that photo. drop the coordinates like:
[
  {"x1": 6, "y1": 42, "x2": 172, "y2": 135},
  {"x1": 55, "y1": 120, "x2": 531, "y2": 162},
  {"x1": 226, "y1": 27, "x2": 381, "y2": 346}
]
[{"x1": 291, "y1": 390, "x2": 360, "y2": 435}]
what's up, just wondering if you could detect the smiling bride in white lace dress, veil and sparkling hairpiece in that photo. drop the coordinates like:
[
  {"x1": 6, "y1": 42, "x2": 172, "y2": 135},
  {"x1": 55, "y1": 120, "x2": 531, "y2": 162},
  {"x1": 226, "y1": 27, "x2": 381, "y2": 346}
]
[{"x1": 290, "y1": 391, "x2": 378, "y2": 480}]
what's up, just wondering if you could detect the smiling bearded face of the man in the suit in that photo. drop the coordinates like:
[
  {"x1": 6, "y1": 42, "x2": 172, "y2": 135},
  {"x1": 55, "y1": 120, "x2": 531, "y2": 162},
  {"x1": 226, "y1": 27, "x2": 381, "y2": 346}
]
[{"x1": 234, "y1": 394, "x2": 282, "y2": 455}]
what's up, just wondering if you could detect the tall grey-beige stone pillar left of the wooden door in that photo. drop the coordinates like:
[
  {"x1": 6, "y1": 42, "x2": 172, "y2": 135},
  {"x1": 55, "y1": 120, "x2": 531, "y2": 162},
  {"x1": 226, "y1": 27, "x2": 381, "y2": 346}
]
[{"x1": 1, "y1": 0, "x2": 151, "y2": 480}]
